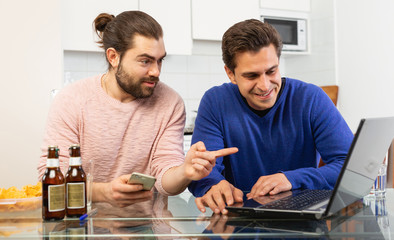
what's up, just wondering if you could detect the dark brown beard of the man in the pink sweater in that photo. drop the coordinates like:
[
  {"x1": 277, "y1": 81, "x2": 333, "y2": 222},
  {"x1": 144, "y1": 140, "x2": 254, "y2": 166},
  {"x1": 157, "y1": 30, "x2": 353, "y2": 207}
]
[{"x1": 115, "y1": 64, "x2": 159, "y2": 98}]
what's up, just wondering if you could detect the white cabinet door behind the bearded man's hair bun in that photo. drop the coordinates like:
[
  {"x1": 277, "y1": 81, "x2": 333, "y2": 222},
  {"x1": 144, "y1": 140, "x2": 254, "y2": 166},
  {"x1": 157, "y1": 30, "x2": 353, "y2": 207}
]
[{"x1": 61, "y1": 0, "x2": 138, "y2": 51}]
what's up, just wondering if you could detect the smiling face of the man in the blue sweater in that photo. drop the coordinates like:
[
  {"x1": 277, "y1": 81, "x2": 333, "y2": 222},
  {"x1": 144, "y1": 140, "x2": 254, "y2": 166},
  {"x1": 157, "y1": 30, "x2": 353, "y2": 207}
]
[{"x1": 225, "y1": 44, "x2": 282, "y2": 111}]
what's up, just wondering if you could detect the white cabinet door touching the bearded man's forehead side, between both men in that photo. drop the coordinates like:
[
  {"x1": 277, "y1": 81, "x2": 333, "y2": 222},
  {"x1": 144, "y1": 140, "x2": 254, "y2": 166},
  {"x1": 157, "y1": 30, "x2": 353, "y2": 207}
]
[{"x1": 139, "y1": 0, "x2": 193, "y2": 55}]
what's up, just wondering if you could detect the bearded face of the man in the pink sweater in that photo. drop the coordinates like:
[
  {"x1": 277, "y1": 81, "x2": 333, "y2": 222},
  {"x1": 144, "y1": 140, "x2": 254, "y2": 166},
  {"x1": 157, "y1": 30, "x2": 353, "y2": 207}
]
[{"x1": 115, "y1": 35, "x2": 166, "y2": 98}]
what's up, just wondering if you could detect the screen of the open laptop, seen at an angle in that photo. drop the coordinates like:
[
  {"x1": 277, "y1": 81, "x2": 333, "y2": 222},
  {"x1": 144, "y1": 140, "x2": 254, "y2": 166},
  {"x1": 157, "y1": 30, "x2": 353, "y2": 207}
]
[{"x1": 325, "y1": 117, "x2": 394, "y2": 215}]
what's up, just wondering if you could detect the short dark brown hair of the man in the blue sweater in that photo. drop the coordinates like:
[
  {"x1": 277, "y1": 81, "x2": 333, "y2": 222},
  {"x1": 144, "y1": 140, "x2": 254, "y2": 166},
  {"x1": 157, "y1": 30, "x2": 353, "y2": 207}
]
[{"x1": 222, "y1": 19, "x2": 282, "y2": 72}]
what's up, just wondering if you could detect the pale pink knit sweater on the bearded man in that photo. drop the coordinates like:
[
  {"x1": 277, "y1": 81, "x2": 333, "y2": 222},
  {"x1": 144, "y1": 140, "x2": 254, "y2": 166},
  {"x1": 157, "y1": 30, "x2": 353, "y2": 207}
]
[{"x1": 38, "y1": 75, "x2": 185, "y2": 194}]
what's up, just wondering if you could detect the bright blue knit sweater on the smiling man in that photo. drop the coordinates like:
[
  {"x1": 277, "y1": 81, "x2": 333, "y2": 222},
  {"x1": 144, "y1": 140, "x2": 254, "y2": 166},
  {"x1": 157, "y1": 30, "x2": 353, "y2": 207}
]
[{"x1": 189, "y1": 78, "x2": 353, "y2": 197}]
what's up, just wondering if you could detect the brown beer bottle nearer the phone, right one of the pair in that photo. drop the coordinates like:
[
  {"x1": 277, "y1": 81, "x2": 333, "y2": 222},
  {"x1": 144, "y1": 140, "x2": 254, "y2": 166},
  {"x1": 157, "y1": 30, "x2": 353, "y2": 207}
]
[{"x1": 66, "y1": 144, "x2": 87, "y2": 217}]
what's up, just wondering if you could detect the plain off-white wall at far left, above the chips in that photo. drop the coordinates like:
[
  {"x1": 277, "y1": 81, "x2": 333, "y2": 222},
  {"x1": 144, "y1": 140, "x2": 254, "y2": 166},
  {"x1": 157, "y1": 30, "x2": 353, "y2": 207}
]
[{"x1": 0, "y1": 0, "x2": 62, "y2": 188}]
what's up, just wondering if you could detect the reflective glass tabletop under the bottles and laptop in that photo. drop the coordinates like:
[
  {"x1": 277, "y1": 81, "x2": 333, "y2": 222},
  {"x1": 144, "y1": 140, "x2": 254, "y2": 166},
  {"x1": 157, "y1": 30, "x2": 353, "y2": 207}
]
[{"x1": 0, "y1": 189, "x2": 394, "y2": 239}]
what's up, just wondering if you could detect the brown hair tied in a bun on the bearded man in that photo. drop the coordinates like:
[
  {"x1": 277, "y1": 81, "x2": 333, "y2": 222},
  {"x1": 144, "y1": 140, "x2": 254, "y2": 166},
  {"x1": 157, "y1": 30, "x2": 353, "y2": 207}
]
[{"x1": 93, "y1": 11, "x2": 163, "y2": 68}]
